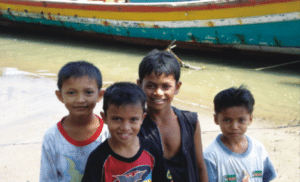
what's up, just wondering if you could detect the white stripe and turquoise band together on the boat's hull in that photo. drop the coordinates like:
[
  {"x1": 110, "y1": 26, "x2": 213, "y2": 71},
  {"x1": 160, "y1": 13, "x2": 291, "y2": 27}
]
[{"x1": 0, "y1": 0, "x2": 300, "y2": 55}]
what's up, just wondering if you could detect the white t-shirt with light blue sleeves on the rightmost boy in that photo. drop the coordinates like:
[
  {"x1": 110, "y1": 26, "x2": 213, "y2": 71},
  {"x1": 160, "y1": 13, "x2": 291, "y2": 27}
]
[{"x1": 204, "y1": 134, "x2": 277, "y2": 182}]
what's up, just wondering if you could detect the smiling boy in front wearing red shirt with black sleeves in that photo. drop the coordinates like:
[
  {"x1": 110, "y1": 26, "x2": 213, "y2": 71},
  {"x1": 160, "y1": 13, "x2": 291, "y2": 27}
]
[{"x1": 82, "y1": 82, "x2": 172, "y2": 182}]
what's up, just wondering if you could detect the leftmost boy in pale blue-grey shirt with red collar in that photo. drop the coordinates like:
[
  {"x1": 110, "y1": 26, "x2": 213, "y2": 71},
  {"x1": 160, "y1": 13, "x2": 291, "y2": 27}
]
[{"x1": 40, "y1": 61, "x2": 109, "y2": 182}]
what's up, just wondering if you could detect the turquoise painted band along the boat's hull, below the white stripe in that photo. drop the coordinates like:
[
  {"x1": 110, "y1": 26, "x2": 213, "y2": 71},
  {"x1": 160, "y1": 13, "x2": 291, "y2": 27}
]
[{"x1": 3, "y1": 16, "x2": 300, "y2": 47}]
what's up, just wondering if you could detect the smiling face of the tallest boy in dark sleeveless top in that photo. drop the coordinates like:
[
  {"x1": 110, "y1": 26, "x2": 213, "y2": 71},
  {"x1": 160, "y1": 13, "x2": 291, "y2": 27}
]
[{"x1": 138, "y1": 72, "x2": 182, "y2": 110}]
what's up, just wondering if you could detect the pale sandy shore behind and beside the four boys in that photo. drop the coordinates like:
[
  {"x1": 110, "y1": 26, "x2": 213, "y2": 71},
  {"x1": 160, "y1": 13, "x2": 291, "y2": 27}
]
[{"x1": 0, "y1": 76, "x2": 300, "y2": 182}]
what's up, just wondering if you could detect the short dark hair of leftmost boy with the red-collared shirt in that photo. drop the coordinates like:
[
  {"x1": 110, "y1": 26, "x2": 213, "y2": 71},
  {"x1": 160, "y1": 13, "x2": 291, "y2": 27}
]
[{"x1": 57, "y1": 61, "x2": 102, "y2": 90}]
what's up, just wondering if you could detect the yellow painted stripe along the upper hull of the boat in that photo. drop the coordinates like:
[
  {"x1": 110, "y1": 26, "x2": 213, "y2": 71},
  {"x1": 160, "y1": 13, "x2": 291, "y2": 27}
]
[{"x1": 0, "y1": 1, "x2": 300, "y2": 21}]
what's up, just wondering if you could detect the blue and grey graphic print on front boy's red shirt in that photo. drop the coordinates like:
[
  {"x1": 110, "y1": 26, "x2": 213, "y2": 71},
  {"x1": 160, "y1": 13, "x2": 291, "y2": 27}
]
[{"x1": 113, "y1": 166, "x2": 151, "y2": 182}]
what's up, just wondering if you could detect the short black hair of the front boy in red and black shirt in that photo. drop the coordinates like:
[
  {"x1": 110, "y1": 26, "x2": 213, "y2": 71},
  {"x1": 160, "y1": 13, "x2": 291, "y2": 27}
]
[{"x1": 103, "y1": 82, "x2": 147, "y2": 114}]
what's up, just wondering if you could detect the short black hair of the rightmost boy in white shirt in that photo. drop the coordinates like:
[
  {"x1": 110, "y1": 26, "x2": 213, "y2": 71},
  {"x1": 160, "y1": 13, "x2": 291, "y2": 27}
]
[{"x1": 214, "y1": 85, "x2": 255, "y2": 114}]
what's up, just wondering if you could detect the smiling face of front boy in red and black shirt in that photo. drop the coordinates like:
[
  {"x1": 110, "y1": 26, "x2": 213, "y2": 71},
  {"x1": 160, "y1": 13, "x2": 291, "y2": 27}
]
[{"x1": 101, "y1": 104, "x2": 146, "y2": 146}]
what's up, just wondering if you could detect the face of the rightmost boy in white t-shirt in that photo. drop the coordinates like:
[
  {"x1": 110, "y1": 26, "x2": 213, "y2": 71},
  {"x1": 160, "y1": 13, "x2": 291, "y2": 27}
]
[{"x1": 215, "y1": 106, "x2": 253, "y2": 141}]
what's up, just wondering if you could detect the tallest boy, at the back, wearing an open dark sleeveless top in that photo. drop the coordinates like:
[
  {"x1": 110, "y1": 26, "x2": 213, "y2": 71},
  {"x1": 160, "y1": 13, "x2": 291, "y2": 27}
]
[{"x1": 137, "y1": 50, "x2": 208, "y2": 182}]
